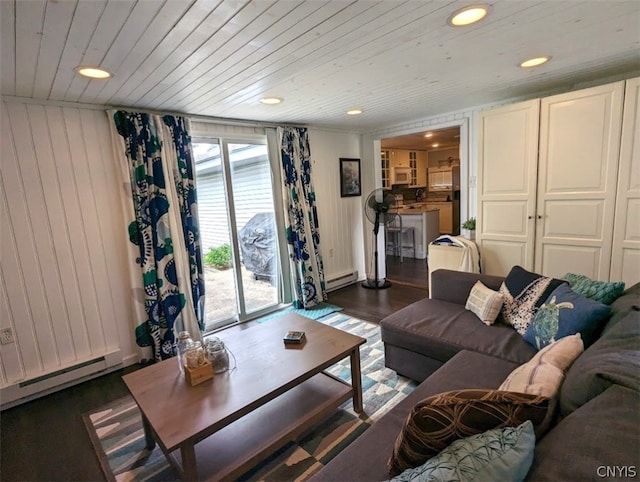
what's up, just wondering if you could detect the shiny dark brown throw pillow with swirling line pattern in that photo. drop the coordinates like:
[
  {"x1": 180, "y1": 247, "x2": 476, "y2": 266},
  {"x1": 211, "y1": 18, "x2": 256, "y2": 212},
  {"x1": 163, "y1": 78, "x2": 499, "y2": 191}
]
[{"x1": 387, "y1": 389, "x2": 550, "y2": 477}]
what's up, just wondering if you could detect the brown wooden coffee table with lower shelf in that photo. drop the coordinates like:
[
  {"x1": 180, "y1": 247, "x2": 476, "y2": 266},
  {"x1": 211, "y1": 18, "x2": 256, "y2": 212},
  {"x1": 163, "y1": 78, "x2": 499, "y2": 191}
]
[{"x1": 123, "y1": 314, "x2": 366, "y2": 480}]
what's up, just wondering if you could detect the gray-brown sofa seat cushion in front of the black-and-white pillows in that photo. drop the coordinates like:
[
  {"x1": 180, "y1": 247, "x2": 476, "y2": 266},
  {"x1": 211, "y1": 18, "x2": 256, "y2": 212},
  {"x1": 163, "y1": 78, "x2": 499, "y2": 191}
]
[{"x1": 380, "y1": 299, "x2": 537, "y2": 364}]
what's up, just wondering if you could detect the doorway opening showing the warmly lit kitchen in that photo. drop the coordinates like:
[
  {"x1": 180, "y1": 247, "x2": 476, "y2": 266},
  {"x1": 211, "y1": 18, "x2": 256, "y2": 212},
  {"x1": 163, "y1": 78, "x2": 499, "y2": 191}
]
[{"x1": 380, "y1": 123, "x2": 460, "y2": 289}]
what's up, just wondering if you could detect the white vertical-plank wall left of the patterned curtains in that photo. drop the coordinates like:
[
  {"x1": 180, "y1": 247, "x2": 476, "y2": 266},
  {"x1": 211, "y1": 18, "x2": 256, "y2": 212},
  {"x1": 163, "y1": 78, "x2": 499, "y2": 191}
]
[{"x1": 0, "y1": 101, "x2": 133, "y2": 403}]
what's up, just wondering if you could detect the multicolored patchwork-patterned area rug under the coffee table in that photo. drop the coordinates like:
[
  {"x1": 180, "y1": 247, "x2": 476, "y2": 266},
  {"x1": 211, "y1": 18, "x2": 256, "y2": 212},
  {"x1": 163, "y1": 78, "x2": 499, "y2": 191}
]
[{"x1": 84, "y1": 313, "x2": 417, "y2": 482}]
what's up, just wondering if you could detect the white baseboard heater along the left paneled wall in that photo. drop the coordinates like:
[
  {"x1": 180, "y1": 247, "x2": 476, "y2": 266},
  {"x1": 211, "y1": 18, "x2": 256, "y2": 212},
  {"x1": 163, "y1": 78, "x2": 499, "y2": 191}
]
[{"x1": 0, "y1": 350, "x2": 122, "y2": 410}]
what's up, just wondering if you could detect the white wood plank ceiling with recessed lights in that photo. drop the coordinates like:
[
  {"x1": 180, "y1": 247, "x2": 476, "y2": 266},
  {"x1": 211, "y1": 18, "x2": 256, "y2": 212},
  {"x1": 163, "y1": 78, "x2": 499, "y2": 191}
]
[{"x1": 0, "y1": 0, "x2": 640, "y2": 132}]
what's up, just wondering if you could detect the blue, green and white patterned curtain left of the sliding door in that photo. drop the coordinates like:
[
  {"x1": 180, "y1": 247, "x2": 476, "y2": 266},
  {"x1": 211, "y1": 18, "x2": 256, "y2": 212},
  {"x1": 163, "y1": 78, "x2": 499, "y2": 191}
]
[{"x1": 110, "y1": 111, "x2": 205, "y2": 361}]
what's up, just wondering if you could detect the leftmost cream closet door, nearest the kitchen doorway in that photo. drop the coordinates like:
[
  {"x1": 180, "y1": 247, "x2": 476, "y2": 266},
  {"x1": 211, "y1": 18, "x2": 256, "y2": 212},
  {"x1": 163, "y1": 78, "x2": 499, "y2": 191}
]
[{"x1": 476, "y1": 99, "x2": 540, "y2": 276}]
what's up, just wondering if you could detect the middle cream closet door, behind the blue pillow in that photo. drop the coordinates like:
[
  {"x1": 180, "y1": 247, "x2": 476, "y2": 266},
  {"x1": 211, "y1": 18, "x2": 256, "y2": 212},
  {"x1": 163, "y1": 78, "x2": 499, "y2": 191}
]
[{"x1": 535, "y1": 82, "x2": 624, "y2": 280}]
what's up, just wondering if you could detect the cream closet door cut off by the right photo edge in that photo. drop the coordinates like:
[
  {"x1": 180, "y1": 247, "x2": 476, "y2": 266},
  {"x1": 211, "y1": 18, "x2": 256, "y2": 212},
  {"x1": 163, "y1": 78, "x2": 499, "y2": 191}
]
[{"x1": 611, "y1": 78, "x2": 640, "y2": 286}]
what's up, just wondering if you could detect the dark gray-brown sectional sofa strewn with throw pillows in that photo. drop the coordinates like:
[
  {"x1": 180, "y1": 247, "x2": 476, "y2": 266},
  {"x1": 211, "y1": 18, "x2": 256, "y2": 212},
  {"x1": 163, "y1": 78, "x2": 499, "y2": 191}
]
[{"x1": 312, "y1": 270, "x2": 640, "y2": 482}]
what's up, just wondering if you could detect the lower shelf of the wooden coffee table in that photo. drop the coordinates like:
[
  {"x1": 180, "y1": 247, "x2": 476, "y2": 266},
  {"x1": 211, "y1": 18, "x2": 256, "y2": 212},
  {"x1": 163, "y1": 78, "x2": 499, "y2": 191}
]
[{"x1": 168, "y1": 373, "x2": 353, "y2": 480}]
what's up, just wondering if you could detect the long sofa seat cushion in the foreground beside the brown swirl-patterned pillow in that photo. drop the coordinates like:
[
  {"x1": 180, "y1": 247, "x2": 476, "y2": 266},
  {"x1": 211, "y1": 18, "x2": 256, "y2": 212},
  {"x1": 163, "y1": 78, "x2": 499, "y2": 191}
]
[{"x1": 311, "y1": 350, "x2": 517, "y2": 482}]
